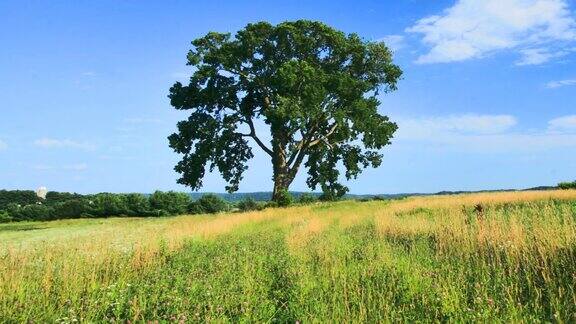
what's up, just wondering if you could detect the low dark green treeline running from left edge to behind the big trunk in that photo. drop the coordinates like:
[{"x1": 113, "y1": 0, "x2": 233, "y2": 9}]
[{"x1": 0, "y1": 190, "x2": 324, "y2": 223}]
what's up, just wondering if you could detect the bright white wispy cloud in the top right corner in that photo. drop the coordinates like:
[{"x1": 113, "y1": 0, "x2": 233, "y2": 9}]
[{"x1": 406, "y1": 0, "x2": 576, "y2": 65}]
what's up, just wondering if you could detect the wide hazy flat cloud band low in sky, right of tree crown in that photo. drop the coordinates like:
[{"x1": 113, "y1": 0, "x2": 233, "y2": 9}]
[{"x1": 396, "y1": 115, "x2": 576, "y2": 153}]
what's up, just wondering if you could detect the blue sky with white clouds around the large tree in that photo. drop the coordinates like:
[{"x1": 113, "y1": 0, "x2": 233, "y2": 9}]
[{"x1": 0, "y1": 0, "x2": 576, "y2": 193}]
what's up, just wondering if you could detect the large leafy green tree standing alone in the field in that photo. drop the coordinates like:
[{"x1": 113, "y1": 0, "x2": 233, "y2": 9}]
[{"x1": 169, "y1": 20, "x2": 402, "y2": 199}]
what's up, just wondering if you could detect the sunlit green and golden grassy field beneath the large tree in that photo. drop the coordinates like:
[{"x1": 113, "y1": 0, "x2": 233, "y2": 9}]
[{"x1": 0, "y1": 190, "x2": 576, "y2": 322}]
